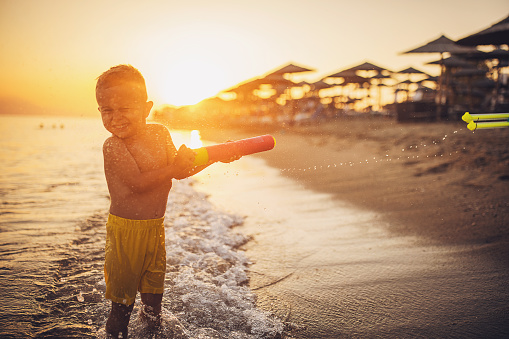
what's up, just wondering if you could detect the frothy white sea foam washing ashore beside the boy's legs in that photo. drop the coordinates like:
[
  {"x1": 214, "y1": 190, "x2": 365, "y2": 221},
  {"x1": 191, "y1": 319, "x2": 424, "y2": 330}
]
[{"x1": 97, "y1": 179, "x2": 284, "y2": 339}]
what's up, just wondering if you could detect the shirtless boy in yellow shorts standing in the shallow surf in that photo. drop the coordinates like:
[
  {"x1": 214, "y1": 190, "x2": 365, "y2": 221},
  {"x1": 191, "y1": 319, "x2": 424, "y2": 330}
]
[{"x1": 96, "y1": 65, "x2": 222, "y2": 338}]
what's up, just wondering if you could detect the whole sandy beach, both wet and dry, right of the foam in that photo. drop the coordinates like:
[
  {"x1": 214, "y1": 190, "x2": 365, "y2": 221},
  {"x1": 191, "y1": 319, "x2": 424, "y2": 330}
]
[{"x1": 195, "y1": 119, "x2": 509, "y2": 338}]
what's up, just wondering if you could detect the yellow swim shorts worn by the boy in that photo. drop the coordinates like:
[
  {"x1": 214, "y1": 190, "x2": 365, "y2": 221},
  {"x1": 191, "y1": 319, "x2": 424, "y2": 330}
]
[{"x1": 104, "y1": 214, "x2": 166, "y2": 305}]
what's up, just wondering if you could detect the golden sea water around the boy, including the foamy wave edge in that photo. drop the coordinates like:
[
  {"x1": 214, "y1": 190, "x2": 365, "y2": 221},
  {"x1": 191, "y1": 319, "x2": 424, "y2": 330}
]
[{"x1": 0, "y1": 116, "x2": 283, "y2": 338}]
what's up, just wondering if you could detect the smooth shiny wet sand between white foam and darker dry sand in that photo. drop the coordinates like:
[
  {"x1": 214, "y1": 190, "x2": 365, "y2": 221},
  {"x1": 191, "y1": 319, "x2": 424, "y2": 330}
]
[{"x1": 192, "y1": 152, "x2": 509, "y2": 338}]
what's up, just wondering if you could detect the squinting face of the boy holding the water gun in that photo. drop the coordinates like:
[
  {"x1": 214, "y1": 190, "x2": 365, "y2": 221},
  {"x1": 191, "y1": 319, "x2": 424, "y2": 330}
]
[{"x1": 96, "y1": 82, "x2": 152, "y2": 139}]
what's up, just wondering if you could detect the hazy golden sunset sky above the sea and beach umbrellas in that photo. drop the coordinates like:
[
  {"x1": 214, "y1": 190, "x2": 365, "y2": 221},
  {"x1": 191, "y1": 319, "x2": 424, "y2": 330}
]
[{"x1": 0, "y1": 0, "x2": 509, "y2": 116}]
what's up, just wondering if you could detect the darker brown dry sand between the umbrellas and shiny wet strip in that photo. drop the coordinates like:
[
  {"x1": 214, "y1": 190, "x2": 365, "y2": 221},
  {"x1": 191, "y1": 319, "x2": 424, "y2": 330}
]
[{"x1": 196, "y1": 117, "x2": 509, "y2": 265}]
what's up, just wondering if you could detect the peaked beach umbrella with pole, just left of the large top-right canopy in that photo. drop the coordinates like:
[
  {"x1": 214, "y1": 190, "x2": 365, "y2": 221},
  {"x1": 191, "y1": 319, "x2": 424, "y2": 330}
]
[{"x1": 403, "y1": 35, "x2": 476, "y2": 120}]
